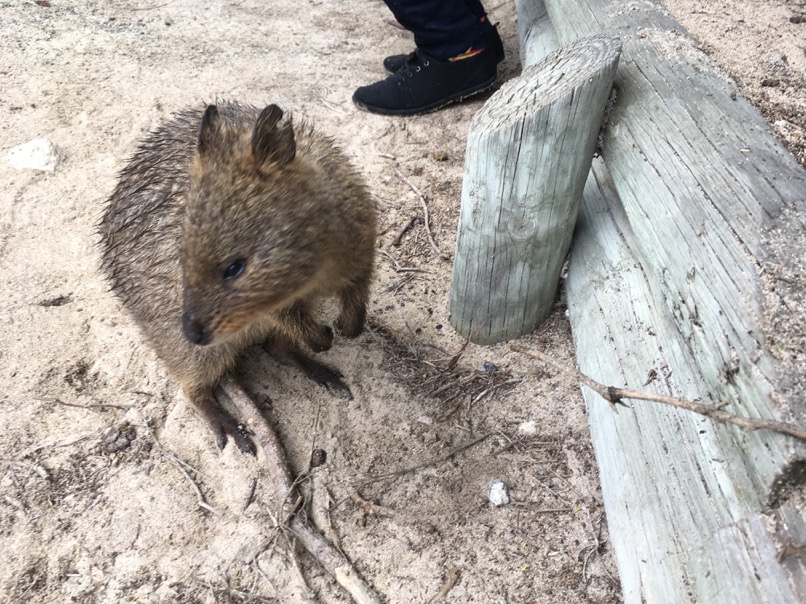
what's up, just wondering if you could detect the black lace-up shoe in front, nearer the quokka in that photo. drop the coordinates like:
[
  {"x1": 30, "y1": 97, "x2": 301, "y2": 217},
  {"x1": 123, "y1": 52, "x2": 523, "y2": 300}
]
[{"x1": 353, "y1": 50, "x2": 497, "y2": 115}]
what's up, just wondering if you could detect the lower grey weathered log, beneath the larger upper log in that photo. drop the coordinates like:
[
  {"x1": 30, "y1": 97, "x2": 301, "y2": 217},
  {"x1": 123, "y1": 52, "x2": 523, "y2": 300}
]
[{"x1": 567, "y1": 160, "x2": 806, "y2": 604}]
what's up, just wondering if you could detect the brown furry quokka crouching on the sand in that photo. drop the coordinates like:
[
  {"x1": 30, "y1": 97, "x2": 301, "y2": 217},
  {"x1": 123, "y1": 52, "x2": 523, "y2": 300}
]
[{"x1": 100, "y1": 102, "x2": 376, "y2": 452}]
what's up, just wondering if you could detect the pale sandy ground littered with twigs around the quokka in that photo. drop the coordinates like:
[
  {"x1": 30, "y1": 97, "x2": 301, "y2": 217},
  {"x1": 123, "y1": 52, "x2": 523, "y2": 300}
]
[{"x1": 0, "y1": 0, "x2": 806, "y2": 603}]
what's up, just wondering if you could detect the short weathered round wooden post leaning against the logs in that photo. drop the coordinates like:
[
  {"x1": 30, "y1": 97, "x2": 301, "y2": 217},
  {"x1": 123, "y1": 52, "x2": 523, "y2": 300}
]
[{"x1": 450, "y1": 36, "x2": 621, "y2": 344}]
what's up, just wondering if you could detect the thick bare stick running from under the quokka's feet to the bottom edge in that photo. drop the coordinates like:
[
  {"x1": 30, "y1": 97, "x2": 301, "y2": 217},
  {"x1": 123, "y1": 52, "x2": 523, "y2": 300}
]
[{"x1": 219, "y1": 376, "x2": 381, "y2": 604}]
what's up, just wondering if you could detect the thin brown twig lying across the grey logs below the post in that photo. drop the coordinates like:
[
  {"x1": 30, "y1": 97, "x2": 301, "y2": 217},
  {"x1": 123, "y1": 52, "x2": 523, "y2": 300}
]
[{"x1": 509, "y1": 344, "x2": 806, "y2": 440}]
